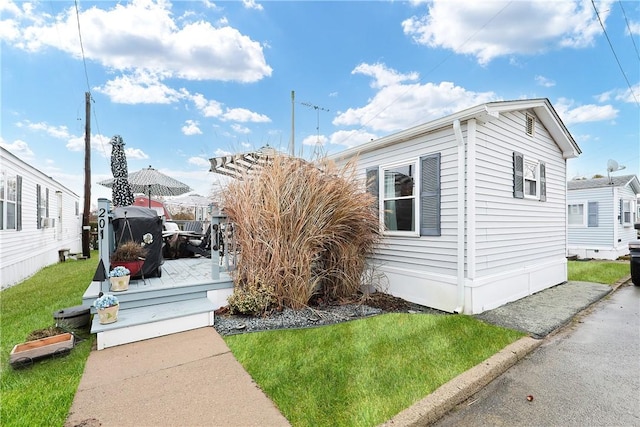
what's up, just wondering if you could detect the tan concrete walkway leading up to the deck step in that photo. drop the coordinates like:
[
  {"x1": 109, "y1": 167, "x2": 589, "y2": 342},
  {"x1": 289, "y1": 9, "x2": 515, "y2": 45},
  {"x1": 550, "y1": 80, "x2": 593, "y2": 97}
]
[{"x1": 65, "y1": 328, "x2": 289, "y2": 427}]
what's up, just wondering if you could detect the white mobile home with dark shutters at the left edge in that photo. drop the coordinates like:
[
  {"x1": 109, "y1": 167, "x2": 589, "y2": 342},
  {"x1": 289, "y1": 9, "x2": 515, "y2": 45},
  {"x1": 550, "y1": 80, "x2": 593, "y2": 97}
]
[{"x1": 0, "y1": 147, "x2": 82, "y2": 289}]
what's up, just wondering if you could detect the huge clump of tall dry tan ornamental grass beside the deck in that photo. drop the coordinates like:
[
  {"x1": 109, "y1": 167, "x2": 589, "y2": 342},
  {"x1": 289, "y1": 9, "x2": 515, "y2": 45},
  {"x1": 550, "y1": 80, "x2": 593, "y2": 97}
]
[{"x1": 223, "y1": 155, "x2": 380, "y2": 314}]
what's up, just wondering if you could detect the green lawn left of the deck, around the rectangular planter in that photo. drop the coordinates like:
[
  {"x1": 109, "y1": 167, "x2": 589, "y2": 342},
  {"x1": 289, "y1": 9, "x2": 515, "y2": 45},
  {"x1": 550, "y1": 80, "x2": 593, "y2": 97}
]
[{"x1": 0, "y1": 252, "x2": 98, "y2": 427}]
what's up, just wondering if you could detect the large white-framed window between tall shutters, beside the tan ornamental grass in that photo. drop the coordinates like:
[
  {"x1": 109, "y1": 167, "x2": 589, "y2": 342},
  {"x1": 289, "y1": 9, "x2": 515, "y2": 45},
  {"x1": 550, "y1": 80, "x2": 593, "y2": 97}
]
[{"x1": 381, "y1": 161, "x2": 418, "y2": 233}]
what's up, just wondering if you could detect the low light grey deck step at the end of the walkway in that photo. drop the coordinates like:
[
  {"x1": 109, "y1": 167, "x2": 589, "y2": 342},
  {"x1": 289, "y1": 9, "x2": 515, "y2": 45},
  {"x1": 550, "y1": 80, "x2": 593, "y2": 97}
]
[{"x1": 91, "y1": 298, "x2": 216, "y2": 350}]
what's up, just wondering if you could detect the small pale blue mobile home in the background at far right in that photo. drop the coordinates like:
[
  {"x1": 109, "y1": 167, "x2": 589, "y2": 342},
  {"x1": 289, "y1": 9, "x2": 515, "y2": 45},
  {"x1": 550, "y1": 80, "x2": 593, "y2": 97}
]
[{"x1": 567, "y1": 175, "x2": 640, "y2": 259}]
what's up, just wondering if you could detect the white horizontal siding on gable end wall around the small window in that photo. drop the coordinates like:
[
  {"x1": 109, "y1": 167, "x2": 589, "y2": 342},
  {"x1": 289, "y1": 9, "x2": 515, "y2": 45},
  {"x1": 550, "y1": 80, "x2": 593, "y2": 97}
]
[{"x1": 475, "y1": 112, "x2": 567, "y2": 277}]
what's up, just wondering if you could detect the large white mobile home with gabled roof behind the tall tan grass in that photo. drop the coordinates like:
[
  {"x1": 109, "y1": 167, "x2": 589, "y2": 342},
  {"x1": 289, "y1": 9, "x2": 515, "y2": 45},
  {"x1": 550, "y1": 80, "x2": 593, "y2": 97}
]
[{"x1": 333, "y1": 99, "x2": 580, "y2": 313}]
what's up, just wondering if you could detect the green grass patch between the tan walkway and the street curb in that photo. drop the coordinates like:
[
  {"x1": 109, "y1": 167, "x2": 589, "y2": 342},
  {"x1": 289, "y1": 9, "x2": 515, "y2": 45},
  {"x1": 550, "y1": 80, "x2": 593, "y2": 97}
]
[{"x1": 225, "y1": 313, "x2": 523, "y2": 426}]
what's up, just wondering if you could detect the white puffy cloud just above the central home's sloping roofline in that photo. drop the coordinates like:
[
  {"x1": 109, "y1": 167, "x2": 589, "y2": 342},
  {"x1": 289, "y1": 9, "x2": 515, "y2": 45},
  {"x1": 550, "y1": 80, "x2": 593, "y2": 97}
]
[{"x1": 332, "y1": 64, "x2": 497, "y2": 132}]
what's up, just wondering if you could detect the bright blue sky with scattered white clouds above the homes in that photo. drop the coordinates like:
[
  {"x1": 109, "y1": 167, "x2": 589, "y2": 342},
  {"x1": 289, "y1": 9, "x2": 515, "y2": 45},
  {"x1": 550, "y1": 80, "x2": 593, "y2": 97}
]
[{"x1": 0, "y1": 0, "x2": 640, "y2": 203}]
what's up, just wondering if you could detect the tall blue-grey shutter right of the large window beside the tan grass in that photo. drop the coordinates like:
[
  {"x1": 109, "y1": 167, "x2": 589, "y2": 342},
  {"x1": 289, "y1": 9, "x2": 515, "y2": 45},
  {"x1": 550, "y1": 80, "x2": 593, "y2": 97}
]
[{"x1": 420, "y1": 153, "x2": 440, "y2": 236}]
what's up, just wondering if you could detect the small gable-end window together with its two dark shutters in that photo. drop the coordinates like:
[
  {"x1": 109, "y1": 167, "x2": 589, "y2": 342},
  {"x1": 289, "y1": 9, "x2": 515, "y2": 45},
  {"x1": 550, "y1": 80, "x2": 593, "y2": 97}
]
[{"x1": 513, "y1": 152, "x2": 547, "y2": 202}]
